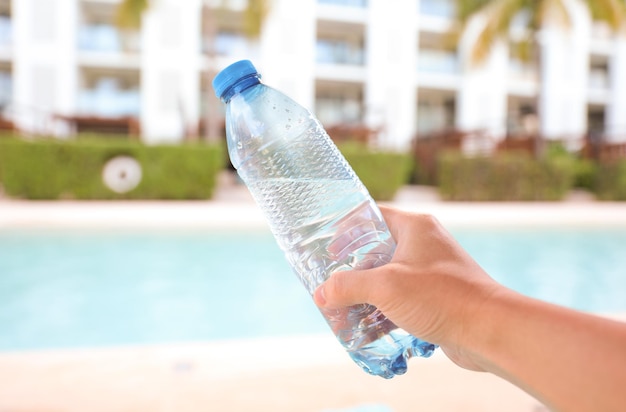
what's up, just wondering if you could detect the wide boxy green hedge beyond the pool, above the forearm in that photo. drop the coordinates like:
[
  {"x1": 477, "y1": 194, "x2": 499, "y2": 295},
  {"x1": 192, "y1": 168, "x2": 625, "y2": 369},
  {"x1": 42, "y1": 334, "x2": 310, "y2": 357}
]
[{"x1": 439, "y1": 152, "x2": 575, "y2": 201}]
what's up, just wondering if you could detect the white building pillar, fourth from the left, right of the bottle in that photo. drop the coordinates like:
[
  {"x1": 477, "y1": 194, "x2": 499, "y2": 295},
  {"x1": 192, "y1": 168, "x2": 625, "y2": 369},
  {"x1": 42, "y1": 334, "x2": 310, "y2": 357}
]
[{"x1": 365, "y1": 0, "x2": 418, "y2": 150}]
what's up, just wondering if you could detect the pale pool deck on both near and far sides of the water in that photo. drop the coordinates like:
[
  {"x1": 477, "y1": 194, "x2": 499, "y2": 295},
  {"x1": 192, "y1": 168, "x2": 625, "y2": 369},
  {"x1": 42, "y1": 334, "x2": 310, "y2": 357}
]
[{"x1": 0, "y1": 180, "x2": 626, "y2": 412}]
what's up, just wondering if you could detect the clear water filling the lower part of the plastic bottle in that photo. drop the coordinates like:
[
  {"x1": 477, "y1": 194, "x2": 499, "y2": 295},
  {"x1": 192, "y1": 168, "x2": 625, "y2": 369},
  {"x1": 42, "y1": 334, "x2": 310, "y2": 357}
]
[{"x1": 244, "y1": 178, "x2": 434, "y2": 378}]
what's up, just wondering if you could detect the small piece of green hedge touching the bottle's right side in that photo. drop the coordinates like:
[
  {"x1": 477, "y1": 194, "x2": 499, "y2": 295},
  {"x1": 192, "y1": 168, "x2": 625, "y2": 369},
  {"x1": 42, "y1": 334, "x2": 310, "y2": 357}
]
[{"x1": 339, "y1": 143, "x2": 411, "y2": 201}]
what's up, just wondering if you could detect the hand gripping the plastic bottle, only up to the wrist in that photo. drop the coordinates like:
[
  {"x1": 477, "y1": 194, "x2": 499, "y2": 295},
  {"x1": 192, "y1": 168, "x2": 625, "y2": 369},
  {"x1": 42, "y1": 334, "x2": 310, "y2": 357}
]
[{"x1": 314, "y1": 207, "x2": 504, "y2": 370}]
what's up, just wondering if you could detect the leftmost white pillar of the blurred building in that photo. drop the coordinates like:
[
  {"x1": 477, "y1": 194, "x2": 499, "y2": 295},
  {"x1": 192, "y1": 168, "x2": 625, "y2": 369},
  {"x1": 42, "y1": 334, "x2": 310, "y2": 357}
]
[{"x1": 12, "y1": 0, "x2": 78, "y2": 135}]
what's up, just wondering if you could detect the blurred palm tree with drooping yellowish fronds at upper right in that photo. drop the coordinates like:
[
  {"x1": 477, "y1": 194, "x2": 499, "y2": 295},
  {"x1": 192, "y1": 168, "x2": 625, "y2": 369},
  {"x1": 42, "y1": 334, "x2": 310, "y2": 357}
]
[{"x1": 456, "y1": 0, "x2": 626, "y2": 156}]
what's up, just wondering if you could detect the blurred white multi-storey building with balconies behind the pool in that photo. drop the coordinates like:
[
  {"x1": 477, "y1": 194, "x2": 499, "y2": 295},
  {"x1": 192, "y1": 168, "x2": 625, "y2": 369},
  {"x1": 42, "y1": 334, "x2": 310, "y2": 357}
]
[{"x1": 0, "y1": 0, "x2": 626, "y2": 148}]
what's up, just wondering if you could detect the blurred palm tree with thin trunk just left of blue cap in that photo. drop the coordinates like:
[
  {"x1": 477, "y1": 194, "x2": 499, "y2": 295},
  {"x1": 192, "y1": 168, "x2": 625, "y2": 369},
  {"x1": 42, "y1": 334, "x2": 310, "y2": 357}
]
[{"x1": 116, "y1": 0, "x2": 270, "y2": 140}]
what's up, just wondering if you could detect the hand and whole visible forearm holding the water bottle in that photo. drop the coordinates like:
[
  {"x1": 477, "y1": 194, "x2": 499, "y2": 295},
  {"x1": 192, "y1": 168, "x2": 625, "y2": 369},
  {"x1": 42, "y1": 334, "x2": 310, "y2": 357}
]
[{"x1": 313, "y1": 207, "x2": 626, "y2": 412}]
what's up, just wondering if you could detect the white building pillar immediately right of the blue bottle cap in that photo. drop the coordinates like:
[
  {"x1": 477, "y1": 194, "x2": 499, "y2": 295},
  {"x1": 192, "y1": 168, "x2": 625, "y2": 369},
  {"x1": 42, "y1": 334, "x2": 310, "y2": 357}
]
[{"x1": 253, "y1": 0, "x2": 317, "y2": 110}]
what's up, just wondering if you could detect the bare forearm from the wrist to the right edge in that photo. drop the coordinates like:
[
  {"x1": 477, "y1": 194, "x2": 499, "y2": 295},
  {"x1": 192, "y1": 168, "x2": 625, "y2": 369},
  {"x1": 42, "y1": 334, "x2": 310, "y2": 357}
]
[{"x1": 469, "y1": 291, "x2": 626, "y2": 411}]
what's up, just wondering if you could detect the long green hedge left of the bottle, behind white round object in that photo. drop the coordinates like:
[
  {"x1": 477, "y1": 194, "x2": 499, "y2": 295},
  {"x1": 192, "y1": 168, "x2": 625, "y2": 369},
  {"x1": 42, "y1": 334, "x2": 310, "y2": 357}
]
[{"x1": 0, "y1": 137, "x2": 223, "y2": 199}]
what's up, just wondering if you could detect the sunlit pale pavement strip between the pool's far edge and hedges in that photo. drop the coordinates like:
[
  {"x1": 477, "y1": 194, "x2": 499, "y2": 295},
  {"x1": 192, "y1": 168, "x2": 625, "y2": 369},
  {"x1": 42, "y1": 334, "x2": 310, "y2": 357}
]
[{"x1": 0, "y1": 175, "x2": 626, "y2": 229}]
